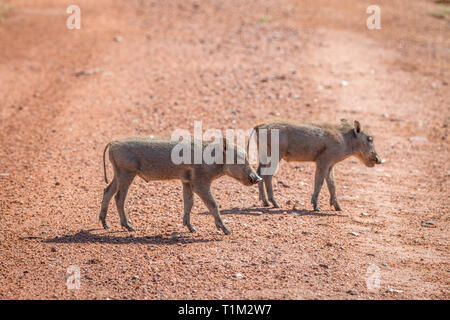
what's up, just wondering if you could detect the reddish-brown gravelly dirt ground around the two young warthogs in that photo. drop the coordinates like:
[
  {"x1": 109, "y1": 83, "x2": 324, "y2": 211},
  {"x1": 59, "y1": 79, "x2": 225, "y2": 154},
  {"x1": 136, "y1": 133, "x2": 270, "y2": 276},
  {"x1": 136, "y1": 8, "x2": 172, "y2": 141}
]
[{"x1": 0, "y1": 0, "x2": 450, "y2": 299}]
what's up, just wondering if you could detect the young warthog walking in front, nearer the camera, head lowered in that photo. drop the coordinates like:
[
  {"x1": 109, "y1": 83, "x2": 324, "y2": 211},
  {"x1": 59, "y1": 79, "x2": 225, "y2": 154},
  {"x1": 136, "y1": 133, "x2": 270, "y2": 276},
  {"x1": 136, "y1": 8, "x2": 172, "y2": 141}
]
[{"x1": 100, "y1": 138, "x2": 261, "y2": 234}]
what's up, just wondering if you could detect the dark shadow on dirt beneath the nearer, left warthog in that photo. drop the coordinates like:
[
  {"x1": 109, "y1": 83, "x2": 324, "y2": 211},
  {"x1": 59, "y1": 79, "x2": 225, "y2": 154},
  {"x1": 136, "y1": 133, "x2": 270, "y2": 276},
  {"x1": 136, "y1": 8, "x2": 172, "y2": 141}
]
[{"x1": 43, "y1": 229, "x2": 221, "y2": 245}]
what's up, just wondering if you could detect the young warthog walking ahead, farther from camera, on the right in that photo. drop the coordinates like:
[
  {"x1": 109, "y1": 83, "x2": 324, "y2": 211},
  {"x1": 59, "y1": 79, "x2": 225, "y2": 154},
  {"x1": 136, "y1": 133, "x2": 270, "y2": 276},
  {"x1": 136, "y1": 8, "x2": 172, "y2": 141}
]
[{"x1": 247, "y1": 119, "x2": 384, "y2": 211}]
